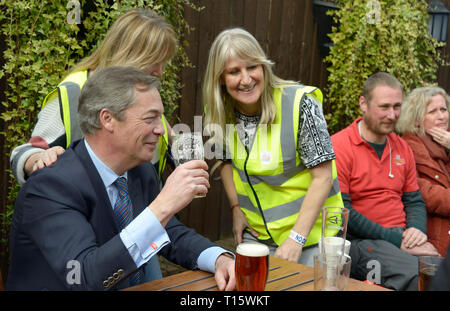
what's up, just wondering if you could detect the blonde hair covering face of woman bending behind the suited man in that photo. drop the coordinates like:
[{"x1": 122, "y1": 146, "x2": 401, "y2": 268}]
[{"x1": 70, "y1": 9, "x2": 177, "y2": 72}]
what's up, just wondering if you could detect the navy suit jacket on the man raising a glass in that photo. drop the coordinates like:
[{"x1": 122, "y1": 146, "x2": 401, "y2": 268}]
[{"x1": 6, "y1": 140, "x2": 217, "y2": 290}]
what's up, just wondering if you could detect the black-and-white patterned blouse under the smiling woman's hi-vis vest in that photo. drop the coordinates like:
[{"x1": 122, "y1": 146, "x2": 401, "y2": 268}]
[{"x1": 235, "y1": 96, "x2": 336, "y2": 168}]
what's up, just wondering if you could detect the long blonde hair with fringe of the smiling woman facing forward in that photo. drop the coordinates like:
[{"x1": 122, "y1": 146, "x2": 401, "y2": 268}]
[{"x1": 202, "y1": 28, "x2": 296, "y2": 143}]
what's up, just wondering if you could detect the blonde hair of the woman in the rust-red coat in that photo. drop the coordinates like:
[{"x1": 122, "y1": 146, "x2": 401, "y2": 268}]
[{"x1": 395, "y1": 86, "x2": 450, "y2": 134}]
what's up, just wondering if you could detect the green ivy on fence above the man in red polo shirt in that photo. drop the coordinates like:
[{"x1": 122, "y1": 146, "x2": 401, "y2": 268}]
[{"x1": 326, "y1": 0, "x2": 442, "y2": 133}]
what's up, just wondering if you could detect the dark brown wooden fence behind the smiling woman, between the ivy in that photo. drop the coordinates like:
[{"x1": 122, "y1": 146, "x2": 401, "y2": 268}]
[{"x1": 179, "y1": 0, "x2": 450, "y2": 243}]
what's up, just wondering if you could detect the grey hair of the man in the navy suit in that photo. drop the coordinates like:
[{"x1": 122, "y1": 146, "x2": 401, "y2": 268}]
[{"x1": 78, "y1": 66, "x2": 159, "y2": 135}]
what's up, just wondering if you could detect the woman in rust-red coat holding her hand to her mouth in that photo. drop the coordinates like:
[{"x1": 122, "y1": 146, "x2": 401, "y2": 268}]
[{"x1": 396, "y1": 86, "x2": 450, "y2": 256}]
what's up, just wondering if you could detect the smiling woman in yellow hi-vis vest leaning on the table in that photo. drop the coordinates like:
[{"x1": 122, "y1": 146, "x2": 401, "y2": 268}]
[{"x1": 203, "y1": 28, "x2": 343, "y2": 265}]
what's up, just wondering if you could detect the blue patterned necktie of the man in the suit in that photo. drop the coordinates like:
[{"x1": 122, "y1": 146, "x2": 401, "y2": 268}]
[{"x1": 114, "y1": 177, "x2": 143, "y2": 286}]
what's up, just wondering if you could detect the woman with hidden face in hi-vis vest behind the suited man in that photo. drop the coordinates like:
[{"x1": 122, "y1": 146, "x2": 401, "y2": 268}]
[{"x1": 10, "y1": 9, "x2": 173, "y2": 184}]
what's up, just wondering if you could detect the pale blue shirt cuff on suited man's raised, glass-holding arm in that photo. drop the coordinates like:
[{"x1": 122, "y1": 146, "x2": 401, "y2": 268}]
[{"x1": 120, "y1": 208, "x2": 170, "y2": 268}]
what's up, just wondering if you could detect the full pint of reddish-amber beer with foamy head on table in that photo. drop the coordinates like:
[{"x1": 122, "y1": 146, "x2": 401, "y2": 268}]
[{"x1": 235, "y1": 242, "x2": 269, "y2": 291}]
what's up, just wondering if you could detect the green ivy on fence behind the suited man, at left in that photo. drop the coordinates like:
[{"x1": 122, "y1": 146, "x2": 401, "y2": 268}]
[{"x1": 0, "y1": 0, "x2": 201, "y2": 247}]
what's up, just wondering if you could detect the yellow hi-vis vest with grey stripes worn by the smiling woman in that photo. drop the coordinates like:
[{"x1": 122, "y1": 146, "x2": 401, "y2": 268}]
[{"x1": 227, "y1": 86, "x2": 343, "y2": 245}]
